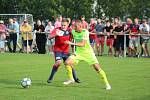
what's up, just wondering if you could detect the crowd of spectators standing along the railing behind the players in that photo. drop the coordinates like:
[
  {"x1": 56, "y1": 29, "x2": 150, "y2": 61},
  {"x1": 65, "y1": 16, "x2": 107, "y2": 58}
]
[{"x1": 0, "y1": 15, "x2": 150, "y2": 57}]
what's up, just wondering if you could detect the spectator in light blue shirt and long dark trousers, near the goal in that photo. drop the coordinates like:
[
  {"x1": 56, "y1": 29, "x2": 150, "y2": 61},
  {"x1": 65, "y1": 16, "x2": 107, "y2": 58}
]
[{"x1": 8, "y1": 19, "x2": 17, "y2": 53}]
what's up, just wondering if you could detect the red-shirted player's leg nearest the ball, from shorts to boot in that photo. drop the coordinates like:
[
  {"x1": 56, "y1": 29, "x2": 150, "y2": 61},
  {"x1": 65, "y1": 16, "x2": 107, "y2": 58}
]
[{"x1": 47, "y1": 52, "x2": 62, "y2": 83}]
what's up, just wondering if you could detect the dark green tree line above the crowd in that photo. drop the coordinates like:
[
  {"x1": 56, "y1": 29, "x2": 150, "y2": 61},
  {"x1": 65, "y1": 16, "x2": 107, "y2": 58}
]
[{"x1": 0, "y1": 0, "x2": 150, "y2": 19}]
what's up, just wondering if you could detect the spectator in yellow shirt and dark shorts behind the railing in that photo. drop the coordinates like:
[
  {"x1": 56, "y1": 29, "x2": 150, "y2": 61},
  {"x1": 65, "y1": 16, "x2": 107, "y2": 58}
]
[{"x1": 20, "y1": 20, "x2": 33, "y2": 52}]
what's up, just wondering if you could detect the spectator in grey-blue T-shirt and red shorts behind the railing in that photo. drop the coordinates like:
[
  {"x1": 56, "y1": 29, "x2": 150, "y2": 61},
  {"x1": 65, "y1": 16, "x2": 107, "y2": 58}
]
[{"x1": 95, "y1": 19, "x2": 105, "y2": 56}]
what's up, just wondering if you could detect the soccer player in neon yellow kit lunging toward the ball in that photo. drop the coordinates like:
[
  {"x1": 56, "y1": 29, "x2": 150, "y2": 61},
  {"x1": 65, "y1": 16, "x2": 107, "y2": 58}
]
[{"x1": 63, "y1": 20, "x2": 111, "y2": 90}]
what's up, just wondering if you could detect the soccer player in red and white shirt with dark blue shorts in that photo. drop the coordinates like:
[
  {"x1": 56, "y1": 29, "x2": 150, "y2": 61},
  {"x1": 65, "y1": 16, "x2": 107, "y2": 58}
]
[{"x1": 47, "y1": 19, "x2": 80, "y2": 83}]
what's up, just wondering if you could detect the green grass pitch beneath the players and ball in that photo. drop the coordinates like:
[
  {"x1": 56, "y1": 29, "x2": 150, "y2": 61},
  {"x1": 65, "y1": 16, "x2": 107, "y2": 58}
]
[{"x1": 0, "y1": 53, "x2": 150, "y2": 100}]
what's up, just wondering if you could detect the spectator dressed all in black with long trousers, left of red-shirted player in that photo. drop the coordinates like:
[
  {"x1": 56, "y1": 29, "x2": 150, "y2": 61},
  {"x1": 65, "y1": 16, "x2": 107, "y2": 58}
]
[{"x1": 34, "y1": 20, "x2": 47, "y2": 54}]
